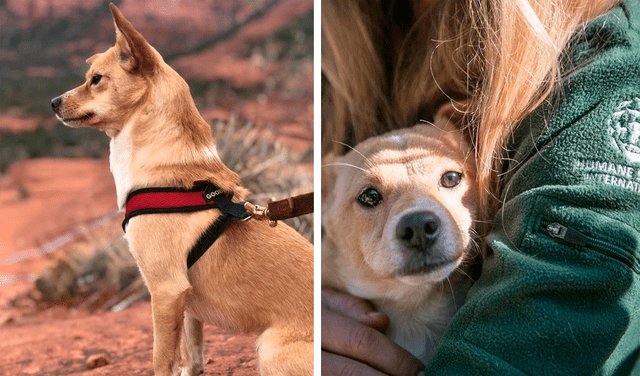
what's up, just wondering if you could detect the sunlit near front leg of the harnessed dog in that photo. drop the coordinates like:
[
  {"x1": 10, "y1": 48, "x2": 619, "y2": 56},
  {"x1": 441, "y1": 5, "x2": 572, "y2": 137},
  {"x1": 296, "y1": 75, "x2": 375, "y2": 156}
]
[{"x1": 151, "y1": 288, "x2": 189, "y2": 376}]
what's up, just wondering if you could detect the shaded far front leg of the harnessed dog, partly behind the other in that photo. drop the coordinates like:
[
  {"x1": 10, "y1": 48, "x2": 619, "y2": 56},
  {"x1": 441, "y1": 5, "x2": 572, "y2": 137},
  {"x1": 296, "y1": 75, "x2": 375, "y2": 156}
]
[{"x1": 180, "y1": 313, "x2": 204, "y2": 376}]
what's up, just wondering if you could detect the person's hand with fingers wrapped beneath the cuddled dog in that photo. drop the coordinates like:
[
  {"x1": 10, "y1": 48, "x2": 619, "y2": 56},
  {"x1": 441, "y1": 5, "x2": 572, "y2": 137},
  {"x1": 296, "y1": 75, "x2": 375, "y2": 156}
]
[{"x1": 321, "y1": 288, "x2": 424, "y2": 376}]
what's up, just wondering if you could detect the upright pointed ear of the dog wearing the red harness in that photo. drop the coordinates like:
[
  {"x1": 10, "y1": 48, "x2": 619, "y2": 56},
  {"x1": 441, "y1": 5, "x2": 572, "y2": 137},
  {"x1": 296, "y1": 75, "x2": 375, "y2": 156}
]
[{"x1": 109, "y1": 3, "x2": 158, "y2": 75}]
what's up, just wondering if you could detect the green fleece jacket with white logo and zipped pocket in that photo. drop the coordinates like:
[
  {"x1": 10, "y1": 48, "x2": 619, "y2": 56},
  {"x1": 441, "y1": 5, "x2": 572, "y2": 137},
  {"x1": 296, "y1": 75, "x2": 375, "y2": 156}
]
[{"x1": 426, "y1": 0, "x2": 640, "y2": 375}]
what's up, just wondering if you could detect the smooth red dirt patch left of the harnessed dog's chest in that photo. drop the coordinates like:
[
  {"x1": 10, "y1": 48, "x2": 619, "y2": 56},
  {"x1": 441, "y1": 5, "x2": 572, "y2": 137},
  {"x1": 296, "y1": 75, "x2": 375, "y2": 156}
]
[{"x1": 0, "y1": 158, "x2": 117, "y2": 256}]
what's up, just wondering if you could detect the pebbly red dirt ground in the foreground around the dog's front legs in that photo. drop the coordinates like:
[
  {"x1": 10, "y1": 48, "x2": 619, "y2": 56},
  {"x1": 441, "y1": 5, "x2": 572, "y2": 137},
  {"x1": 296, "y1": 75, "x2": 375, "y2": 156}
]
[{"x1": 0, "y1": 290, "x2": 257, "y2": 376}]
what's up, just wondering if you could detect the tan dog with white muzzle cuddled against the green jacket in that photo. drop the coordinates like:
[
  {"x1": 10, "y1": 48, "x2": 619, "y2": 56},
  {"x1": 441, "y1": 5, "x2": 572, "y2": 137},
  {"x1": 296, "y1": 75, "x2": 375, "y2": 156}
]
[{"x1": 322, "y1": 113, "x2": 477, "y2": 362}]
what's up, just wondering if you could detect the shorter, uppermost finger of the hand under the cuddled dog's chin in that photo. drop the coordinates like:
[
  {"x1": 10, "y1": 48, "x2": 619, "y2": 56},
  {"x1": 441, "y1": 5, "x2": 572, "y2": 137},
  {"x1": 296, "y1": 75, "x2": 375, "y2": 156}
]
[{"x1": 322, "y1": 288, "x2": 389, "y2": 332}]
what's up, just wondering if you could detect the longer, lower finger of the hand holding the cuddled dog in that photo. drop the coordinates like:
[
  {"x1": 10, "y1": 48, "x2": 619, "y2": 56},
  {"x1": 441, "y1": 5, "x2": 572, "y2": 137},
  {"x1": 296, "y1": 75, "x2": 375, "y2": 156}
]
[{"x1": 321, "y1": 307, "x2": 423, "y2": 376}]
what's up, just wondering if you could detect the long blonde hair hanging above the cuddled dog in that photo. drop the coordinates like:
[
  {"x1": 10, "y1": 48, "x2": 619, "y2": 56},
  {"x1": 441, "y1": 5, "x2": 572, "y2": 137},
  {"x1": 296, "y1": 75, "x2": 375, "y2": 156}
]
[{"x1": 322, "y1": 0, "x2": 619, "y2": 222}]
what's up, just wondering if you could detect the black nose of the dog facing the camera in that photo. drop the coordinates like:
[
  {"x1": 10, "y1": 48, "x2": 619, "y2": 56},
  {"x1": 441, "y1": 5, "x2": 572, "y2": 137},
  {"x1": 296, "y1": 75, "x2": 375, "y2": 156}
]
[{"x1": 396, "y1": 211, "x2": 440, "y2": 253}]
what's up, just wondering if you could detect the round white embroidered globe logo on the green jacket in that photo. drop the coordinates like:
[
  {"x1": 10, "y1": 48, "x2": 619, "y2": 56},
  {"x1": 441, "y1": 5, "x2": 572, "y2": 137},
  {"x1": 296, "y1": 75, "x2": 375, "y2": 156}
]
[{"x1": 607, "y1": 98, "x2": 640, "y2": 163}]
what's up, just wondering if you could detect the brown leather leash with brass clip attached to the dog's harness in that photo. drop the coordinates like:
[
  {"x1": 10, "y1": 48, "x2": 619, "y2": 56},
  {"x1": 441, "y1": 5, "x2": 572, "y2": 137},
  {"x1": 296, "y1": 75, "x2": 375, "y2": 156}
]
[{"x1": 244, "y1": 192, "x2": 313, "y2": 226}]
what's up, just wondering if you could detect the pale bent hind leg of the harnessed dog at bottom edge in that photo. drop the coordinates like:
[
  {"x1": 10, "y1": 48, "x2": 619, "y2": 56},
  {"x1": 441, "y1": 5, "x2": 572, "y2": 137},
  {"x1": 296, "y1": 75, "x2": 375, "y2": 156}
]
[{"x1": 256, "y1": 328, "x2": 313, "y2": 376}]
